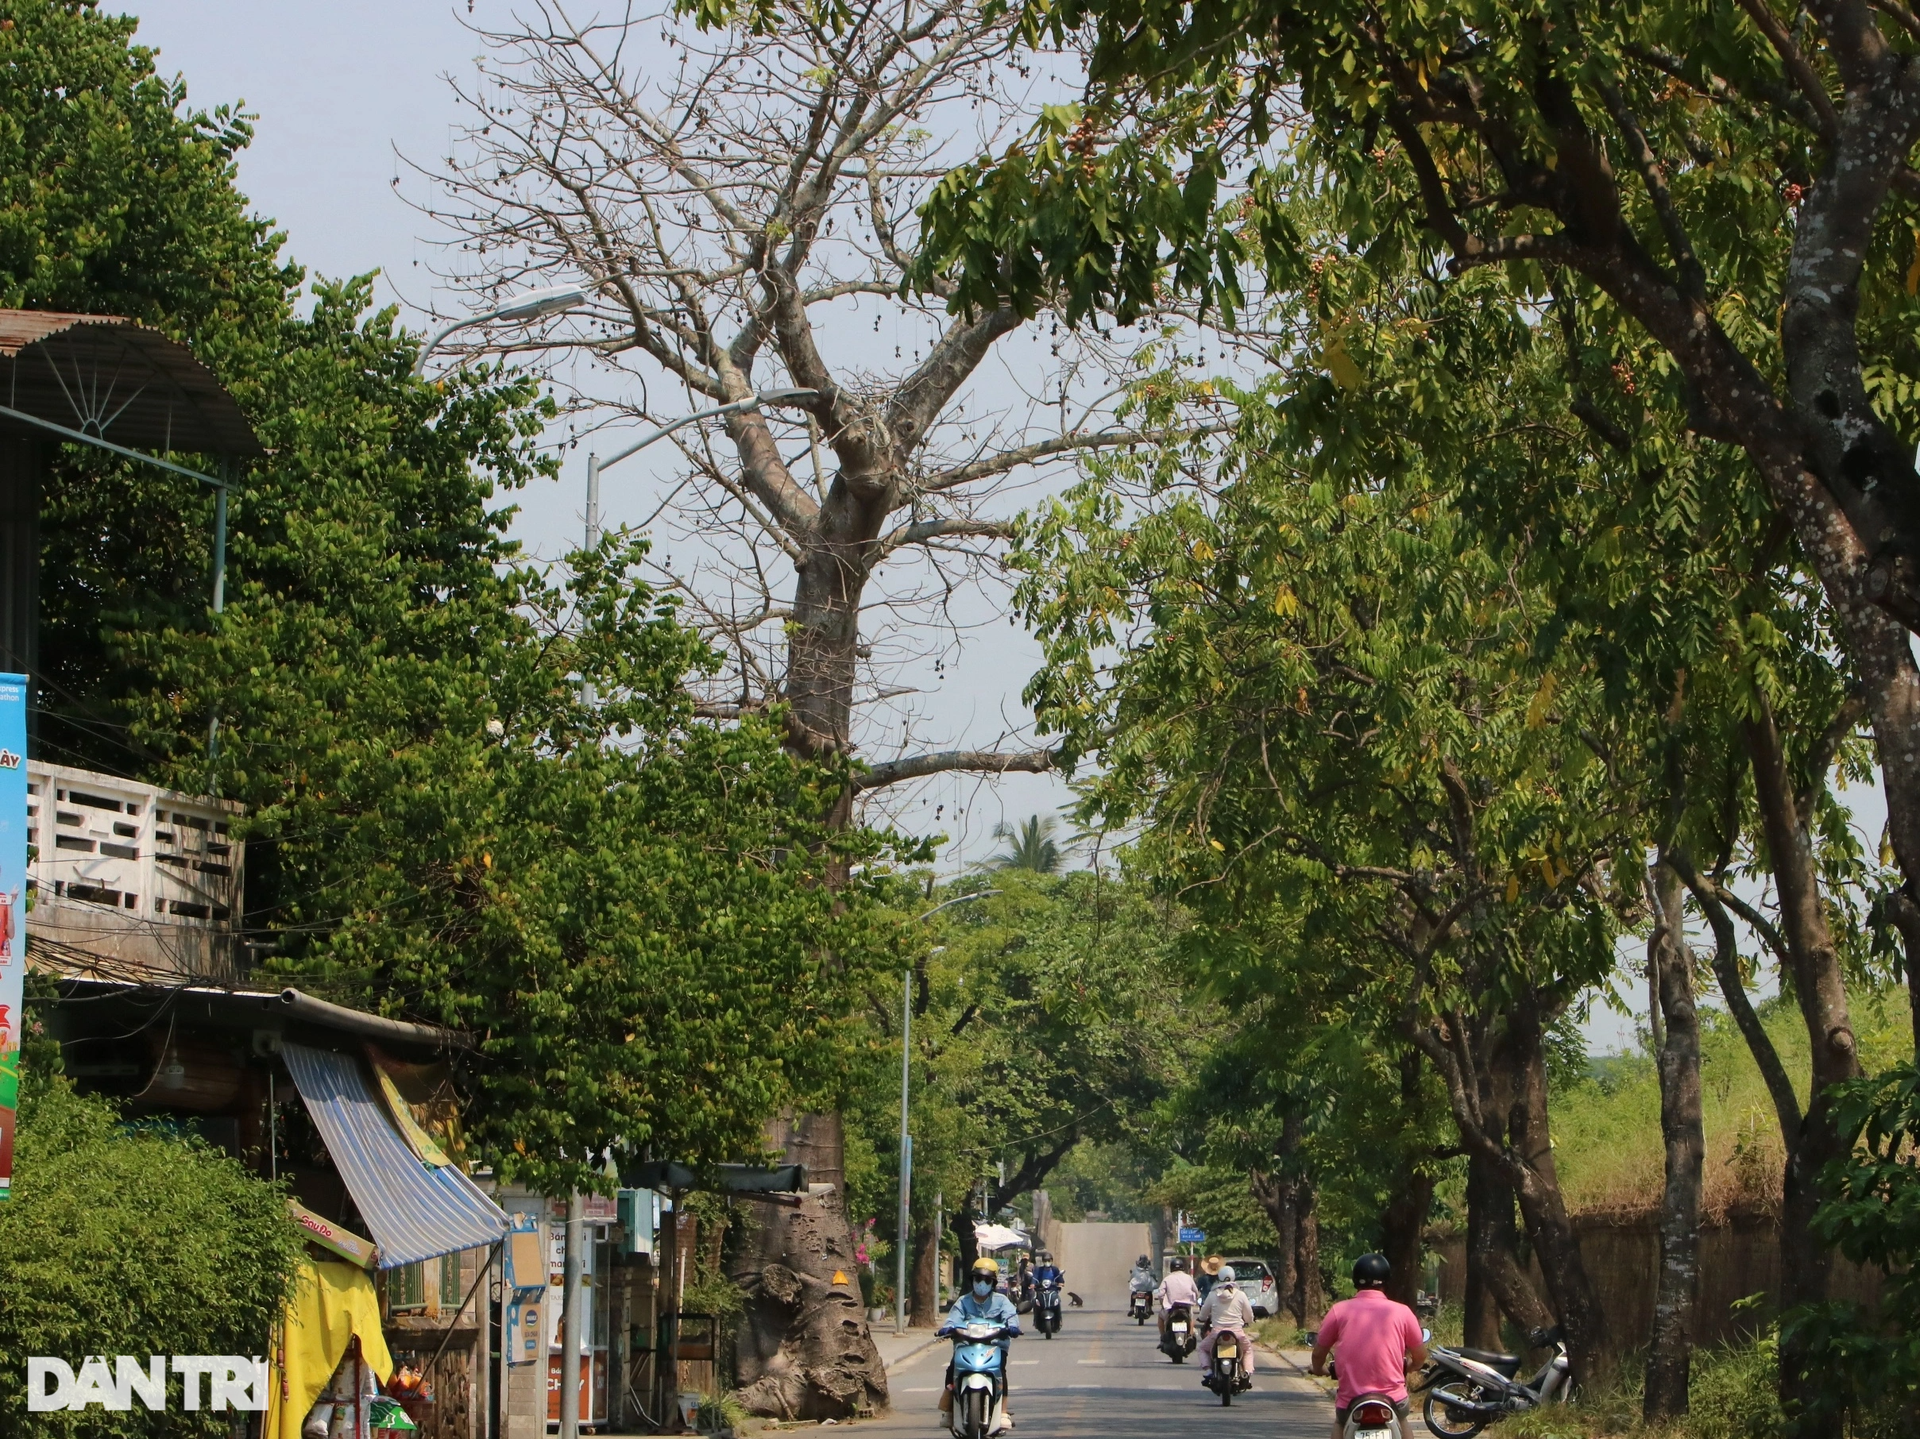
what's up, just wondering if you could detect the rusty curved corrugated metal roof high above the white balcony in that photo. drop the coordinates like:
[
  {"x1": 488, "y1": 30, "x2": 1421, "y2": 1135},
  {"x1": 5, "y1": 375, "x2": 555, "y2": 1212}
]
[{"x1": 0, "y1": 309, "x2": 263, "y2": 455}]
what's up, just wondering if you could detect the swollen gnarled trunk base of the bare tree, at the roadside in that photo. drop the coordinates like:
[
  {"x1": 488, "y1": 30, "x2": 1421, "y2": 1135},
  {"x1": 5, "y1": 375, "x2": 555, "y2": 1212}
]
[{"x1": 732, "y1": 1114, "x2": 887, "y2": 1420}]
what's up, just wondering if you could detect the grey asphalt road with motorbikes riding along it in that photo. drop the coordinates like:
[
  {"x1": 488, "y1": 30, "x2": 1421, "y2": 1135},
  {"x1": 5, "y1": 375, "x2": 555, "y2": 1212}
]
[{"x1": 875, "y1": 1308, "x2": 1332, "y2": 1439}]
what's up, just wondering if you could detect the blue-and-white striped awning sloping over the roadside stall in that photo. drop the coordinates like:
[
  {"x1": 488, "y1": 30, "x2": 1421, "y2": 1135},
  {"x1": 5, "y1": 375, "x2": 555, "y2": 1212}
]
[{"x1": 280, "y1": 1043, "x2": 507, "y2": 1270}]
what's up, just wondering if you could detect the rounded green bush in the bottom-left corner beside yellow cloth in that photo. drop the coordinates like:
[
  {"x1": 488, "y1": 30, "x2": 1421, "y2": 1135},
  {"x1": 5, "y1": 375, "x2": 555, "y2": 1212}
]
[{"x1": 0, "y1": 1082, "x2": 303, "y2": 1439}]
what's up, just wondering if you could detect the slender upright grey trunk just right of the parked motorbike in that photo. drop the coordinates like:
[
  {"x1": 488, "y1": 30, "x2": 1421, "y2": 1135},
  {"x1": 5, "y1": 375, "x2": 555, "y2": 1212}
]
[{"x1": 1642, "y1": 865, "x2": 1707, "y2": 1424}]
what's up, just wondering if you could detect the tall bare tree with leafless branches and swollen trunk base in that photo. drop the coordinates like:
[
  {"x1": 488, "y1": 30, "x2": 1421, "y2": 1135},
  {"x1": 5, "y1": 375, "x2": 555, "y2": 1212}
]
[{"x1": 410, "y1": 0, "x2": 1213, "y2": 1418}]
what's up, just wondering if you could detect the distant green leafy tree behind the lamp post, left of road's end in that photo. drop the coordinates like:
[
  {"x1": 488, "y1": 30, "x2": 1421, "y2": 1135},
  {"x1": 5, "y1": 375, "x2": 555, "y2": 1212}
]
[{"x1": 845, "y1": 868, "x2": 1190, "y2": 1314}]
